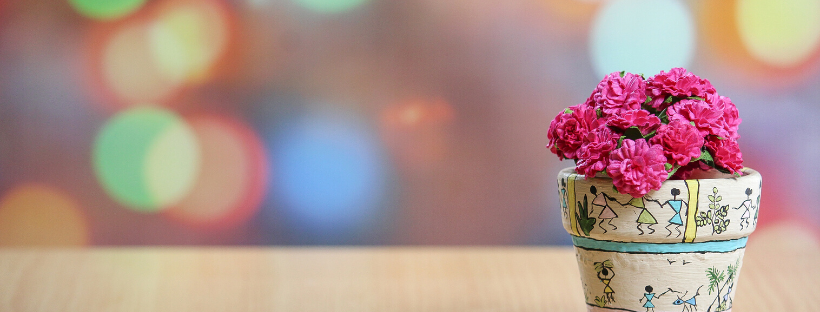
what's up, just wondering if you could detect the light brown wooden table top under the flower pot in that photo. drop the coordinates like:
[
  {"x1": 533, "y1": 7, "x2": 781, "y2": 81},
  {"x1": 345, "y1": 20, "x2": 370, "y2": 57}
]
[{"x1": 0, "y1": 227, "x2": 820, "y2": 312}]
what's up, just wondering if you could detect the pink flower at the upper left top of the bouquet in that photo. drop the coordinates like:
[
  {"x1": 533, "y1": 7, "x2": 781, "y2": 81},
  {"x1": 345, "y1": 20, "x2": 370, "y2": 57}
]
[{"x1": 592, "y1": 72, "x2": 646, "y2": 115}]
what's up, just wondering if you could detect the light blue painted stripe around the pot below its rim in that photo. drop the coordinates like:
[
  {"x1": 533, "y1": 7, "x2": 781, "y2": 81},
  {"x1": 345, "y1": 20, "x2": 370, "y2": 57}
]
[{"x1": 572, "y1": 235, "x2": 746, "y2": 253}]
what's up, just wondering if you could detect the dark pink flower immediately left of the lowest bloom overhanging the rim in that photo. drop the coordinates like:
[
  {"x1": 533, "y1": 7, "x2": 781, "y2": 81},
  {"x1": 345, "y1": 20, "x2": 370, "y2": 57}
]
[{"x1": 575, "y1": 126, "x2": 619, "y2": 178}]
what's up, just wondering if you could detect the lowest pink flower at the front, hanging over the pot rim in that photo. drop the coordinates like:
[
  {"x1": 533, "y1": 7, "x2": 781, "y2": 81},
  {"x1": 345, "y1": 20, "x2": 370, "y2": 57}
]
[{"x1": 606, "y1": 139, "x2": 669, "y2": 197}]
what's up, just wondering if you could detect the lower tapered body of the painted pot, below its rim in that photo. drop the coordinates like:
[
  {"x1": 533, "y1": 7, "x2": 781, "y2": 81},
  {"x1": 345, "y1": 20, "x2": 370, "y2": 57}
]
[{"x1": 575, "y1": 239, "x2": 745, "y2": 312}]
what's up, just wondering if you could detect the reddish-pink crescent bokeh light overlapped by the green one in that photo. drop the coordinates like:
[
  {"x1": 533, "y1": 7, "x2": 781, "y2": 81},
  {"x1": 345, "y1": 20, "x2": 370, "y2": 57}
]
[{"x1": 164, "y1": 115, "x2": 268, "y2": 228}]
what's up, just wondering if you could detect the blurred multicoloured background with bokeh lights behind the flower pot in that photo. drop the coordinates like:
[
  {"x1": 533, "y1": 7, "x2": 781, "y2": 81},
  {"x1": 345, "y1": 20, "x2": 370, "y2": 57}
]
[{"x1": 0, "y1": 0, "x2": 820, "y2": 246}]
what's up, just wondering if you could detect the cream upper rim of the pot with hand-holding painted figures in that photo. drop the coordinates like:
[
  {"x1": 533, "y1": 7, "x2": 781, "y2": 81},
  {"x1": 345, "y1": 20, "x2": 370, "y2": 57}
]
[{"x1": 557, "y1": 167, "x2": 763, "y2": 243}]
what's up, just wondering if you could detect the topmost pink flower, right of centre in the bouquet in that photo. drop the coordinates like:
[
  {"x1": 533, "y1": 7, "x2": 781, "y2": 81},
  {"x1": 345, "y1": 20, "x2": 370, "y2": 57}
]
[{"x1": 646, "y1": 67, "x2": 717, "y2": 111}]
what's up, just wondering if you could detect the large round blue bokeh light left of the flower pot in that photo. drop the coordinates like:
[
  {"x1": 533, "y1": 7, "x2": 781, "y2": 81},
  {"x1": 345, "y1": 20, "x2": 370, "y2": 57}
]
[{"x1": 271, "y1": 114, "x2": 389, "y2": 233}]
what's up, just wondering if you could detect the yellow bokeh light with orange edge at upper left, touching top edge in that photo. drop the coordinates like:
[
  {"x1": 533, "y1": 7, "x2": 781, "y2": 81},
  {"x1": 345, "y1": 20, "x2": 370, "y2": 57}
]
[{"x1": 149, "y1": 0, "x2": 230, "y2": 83}]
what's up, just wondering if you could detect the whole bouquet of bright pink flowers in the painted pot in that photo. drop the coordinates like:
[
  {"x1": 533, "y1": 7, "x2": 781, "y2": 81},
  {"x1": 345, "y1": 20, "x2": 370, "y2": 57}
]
[{"x1": 547, "y1": 68, "x2": 743, "y2": 197}]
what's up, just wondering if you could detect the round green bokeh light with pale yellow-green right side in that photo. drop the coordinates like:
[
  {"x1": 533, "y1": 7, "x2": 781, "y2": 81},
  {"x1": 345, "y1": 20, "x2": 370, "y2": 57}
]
[{"x1": 93, "y1": 107, "x2": 200, "y2": 212}]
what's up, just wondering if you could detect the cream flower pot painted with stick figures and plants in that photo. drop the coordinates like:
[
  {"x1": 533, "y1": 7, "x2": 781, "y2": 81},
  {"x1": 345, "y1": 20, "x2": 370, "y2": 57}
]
[{"x1": 558, "y1": 168, "x2": 762, "y2": 312}]
